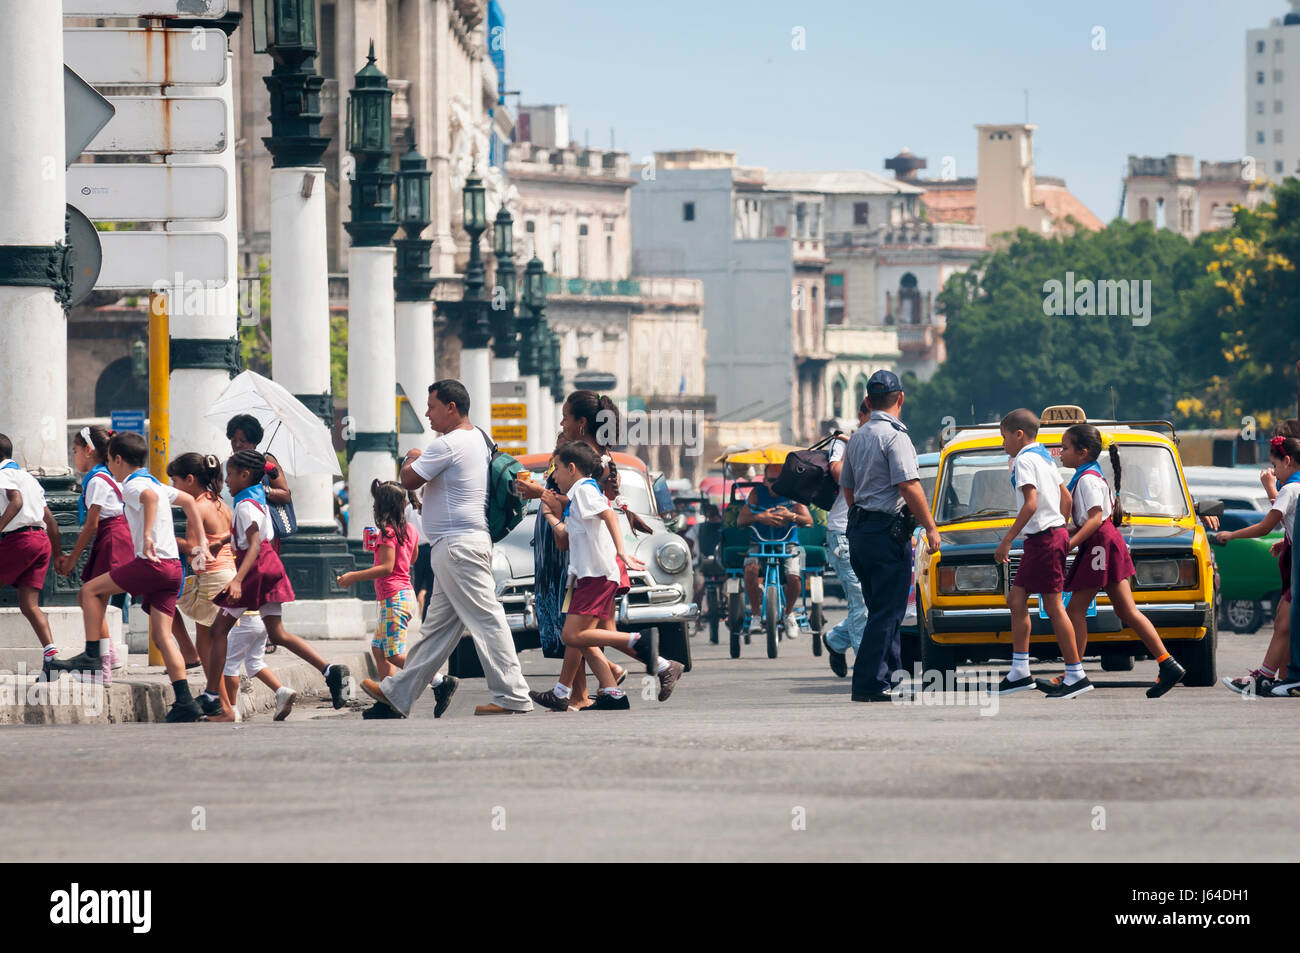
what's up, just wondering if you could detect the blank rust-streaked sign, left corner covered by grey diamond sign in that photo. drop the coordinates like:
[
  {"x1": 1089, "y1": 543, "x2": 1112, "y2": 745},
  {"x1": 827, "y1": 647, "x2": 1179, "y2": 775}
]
[{"x1": 86, "y1": 96, "x2": 226, "y2": 155}]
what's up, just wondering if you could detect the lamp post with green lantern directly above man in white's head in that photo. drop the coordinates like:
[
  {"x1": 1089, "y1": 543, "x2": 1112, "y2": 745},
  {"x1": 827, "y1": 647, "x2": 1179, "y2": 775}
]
[{"x1": 394, "y1": 131, "x2": 436, "y2": 454}]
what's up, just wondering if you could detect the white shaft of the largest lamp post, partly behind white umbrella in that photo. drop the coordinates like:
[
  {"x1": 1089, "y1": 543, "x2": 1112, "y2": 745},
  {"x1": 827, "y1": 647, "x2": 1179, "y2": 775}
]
[{"x1": 270, "y1": 165, "x2": 330, "y2": 530}]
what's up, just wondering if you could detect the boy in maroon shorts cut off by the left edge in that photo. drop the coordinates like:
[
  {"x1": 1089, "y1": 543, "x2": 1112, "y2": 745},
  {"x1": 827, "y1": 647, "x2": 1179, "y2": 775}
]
[{"x1": 0, "y1": 433, "x2": 62, "y2": 663}]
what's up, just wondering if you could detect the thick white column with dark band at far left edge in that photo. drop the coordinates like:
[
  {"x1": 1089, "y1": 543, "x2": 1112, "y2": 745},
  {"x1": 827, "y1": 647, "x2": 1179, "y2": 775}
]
[{"x1": 0, "y1": 0, "x2": 68, "y2": 471}]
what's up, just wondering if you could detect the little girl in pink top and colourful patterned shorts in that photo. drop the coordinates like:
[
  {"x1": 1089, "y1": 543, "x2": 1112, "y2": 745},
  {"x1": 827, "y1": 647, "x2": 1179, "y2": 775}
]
[{"x1": 338, "y1": 480, "x2": 459, "y2": 718}]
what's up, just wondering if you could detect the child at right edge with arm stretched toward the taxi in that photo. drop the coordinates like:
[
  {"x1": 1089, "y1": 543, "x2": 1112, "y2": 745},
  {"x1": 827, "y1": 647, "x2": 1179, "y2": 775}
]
[{"x1": 1214, "y1": 433, "x2": 1300, "y2": 697}]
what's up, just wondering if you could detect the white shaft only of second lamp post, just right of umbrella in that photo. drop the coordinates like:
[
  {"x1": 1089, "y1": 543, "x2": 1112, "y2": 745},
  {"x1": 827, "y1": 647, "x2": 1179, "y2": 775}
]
[{"x1": 347, "y1": 246, "x2": 395, "y2": 540}]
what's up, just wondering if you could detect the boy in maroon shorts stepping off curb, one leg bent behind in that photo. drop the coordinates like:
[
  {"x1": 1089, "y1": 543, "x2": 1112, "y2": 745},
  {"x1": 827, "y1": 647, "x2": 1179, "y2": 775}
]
[{"x1": 49, "y1": 433, "x2": 205, "y2": 722}]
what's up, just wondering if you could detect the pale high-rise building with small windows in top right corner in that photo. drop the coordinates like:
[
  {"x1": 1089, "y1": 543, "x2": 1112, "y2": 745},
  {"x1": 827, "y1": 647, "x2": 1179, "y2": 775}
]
[{"x1": 1243, "y1": 0, "x2": 1300, "y2": 183}]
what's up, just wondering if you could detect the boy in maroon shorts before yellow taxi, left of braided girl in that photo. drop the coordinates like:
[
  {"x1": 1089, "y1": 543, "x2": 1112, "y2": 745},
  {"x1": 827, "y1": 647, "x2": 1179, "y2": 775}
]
[{"x1": 993, "y1": 408, "x2": 1092, "y2": 698}]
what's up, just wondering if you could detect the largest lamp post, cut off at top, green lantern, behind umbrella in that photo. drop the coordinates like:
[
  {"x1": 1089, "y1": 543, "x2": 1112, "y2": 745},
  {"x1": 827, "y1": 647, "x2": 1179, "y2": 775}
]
[{"x1": 256, "y1": 0, "x2": 361, "y2": 637}]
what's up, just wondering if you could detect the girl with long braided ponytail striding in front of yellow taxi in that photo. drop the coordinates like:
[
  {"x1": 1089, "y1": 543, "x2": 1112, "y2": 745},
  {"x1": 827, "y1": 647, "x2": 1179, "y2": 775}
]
[{"x1": 1037, "y1": 424, "x2": 1187, "y2": 698}]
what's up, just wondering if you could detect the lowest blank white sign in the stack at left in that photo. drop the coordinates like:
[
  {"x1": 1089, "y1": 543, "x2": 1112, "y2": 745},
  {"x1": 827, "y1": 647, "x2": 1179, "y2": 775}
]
[{"x1": 95, "y1": 231, "x2": 230, "y2": 291}]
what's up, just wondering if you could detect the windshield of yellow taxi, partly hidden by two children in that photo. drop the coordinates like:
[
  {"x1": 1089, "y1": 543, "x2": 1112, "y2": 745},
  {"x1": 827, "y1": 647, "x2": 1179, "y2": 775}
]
[{"x1": 935, "y1": 443, "x2": 1188, "y2": 523}]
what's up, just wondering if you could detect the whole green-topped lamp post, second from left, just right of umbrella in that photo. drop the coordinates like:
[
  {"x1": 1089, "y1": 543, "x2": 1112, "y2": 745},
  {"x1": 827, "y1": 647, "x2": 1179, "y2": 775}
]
[{"x1": 345, "y1": 42, "x2": 398, "y2": 558}]
